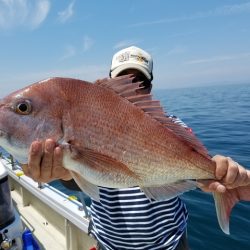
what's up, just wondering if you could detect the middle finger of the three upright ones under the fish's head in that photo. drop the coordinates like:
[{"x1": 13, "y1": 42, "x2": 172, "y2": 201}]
[{"x1": 40, "y1": 139, "x2": 56, "y2": 182}]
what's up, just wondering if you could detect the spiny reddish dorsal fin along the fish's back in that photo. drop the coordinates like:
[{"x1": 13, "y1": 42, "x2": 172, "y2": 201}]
[{"x1": 95, "y1": 75, "x2": 210, "y2": 158}]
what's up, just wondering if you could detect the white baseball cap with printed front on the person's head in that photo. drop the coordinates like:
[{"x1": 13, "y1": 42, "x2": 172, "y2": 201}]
[{"x1": 110, "y1": 46, "x2": 153, "y2": 80}]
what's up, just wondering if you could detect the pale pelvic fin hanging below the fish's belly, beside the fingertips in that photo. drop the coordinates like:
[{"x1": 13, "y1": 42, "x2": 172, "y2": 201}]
[{"x1": 70, "y1": 171, "x2": 100, "y2": 201}]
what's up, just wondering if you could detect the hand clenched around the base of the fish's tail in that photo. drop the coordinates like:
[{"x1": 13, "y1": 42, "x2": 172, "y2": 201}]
[{"x1": 197, "y1": 155, "x2": 250, "y2": 193}]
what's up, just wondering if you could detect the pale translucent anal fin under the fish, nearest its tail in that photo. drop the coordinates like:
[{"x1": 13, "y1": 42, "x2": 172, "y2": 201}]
[{"x1": 141, "y1": 180, "x2": 197, "y2": 201}]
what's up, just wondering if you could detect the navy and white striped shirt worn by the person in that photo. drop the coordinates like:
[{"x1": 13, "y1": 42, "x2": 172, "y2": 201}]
[{"x1": 91, "y1": 116, "x2": 188, "y2": 250}]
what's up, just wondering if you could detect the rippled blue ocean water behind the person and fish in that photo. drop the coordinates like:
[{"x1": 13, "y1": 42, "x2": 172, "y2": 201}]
[{"x1": 0, "y1": 84, "x2": 250, "y2": 250}]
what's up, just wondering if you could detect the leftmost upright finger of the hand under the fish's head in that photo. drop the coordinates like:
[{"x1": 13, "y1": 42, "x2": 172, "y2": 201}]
[{"x1": 27, "y1": 141, "x2": 43, "y2": 181}]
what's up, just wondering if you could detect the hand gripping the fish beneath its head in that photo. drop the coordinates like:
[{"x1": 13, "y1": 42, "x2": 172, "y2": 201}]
[{"x1": 22, "y1": 139, "x2": 72, "y2": 182}]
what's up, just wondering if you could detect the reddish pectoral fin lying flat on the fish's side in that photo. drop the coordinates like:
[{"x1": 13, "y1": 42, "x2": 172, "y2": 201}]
[{"x1": 71, "y1": 145, "x2": 139, "y2": 180}]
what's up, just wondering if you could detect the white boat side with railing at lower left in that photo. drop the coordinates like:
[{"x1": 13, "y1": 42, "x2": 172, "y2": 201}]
[{"x1": 0, "y1": 159, "x2": 95, "y2": 250}]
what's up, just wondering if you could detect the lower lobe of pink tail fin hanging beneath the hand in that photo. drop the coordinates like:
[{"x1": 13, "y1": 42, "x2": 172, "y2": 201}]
[{"x1": 213, "y1": 190, "x2": 239, "y2": 234}]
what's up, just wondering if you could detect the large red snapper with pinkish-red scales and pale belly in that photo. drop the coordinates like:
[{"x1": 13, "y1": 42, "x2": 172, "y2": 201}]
[{"x1": 0, "y1": 76, "x2": 249, "y2": 233}]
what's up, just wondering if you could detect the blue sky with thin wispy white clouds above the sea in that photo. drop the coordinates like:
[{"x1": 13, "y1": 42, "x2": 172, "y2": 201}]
[{"x1": 0, "y1": 0, "x2": 250, "y2": 97}]
